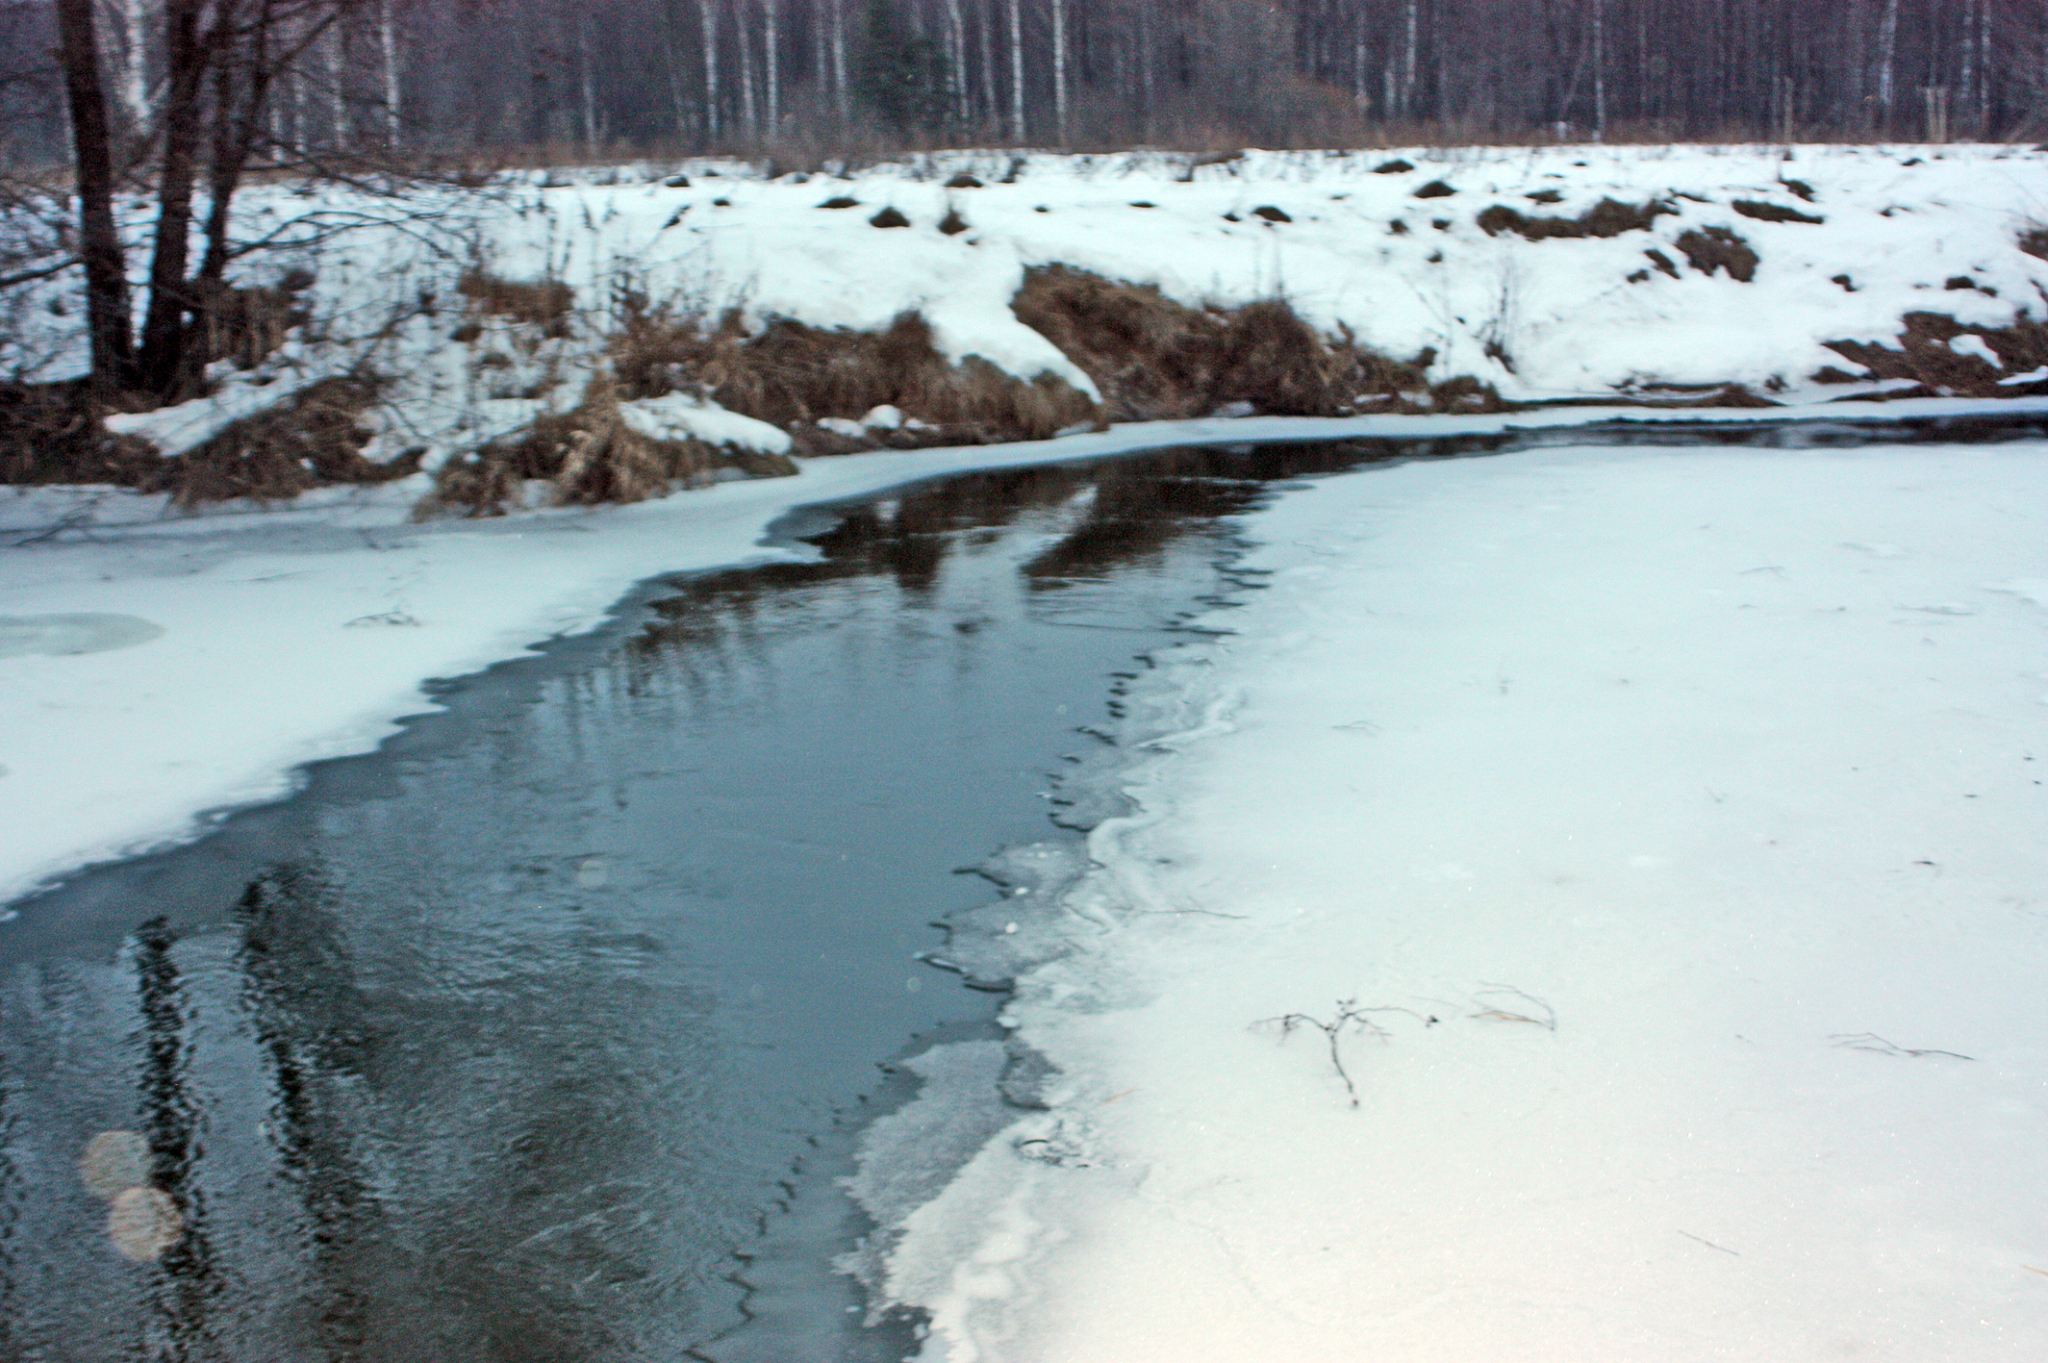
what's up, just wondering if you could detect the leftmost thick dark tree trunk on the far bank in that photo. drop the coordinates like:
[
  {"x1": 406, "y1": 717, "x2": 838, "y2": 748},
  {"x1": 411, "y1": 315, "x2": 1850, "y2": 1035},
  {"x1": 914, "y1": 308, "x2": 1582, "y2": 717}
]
[{"x1": 57, "y1": 0, "x2": 133, "y2": 393}]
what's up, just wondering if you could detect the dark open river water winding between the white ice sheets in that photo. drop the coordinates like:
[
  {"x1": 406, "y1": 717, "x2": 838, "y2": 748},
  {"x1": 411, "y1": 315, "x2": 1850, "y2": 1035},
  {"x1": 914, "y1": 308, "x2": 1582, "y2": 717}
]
[{"x1": 0, "y1": 424, "x2": 2040, "y2": 1363}]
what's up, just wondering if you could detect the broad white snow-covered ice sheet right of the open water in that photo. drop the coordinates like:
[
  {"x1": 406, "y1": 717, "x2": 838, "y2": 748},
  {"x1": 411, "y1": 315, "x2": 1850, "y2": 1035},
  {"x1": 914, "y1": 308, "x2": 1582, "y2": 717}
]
[{"x1": 887, "y1": 444, "x2": 2048, "y2": 1363}]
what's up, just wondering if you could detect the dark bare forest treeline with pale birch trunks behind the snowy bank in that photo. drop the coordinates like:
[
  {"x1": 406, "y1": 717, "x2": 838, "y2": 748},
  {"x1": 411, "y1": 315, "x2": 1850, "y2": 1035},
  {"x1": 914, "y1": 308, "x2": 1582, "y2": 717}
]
[{"x1": 0, "y1": 0, "x2": 2048, "y2": 168}]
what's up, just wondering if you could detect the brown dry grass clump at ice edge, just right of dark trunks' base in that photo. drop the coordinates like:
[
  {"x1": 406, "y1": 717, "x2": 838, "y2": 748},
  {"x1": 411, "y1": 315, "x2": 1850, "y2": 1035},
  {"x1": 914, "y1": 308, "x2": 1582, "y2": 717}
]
[{"x1": 133, "y1": 377, "x2": 420, "y2": 508}]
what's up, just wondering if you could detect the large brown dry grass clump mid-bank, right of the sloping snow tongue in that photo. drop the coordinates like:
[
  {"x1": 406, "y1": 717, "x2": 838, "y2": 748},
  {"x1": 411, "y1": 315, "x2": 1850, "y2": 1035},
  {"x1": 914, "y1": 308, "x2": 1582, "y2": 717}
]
[{"x1": 1012, "y1": 266, "x2": 1458, "y2": 422}]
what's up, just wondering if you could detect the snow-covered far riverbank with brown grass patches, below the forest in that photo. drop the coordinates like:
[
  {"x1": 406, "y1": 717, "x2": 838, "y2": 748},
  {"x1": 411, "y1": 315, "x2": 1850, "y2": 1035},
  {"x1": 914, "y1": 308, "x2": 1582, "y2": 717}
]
[{"x1": 0, "y1": 145, "x2": 2048, "y2": 509}]
